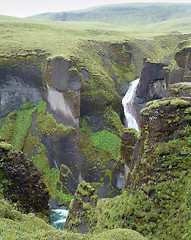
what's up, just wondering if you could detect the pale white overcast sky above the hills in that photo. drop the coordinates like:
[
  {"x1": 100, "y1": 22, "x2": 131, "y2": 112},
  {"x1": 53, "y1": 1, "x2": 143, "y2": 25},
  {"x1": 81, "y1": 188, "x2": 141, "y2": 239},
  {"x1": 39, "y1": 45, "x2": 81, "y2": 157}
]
[{"x1": 0, "y1": 0, "x2": 191, "y2": 17}]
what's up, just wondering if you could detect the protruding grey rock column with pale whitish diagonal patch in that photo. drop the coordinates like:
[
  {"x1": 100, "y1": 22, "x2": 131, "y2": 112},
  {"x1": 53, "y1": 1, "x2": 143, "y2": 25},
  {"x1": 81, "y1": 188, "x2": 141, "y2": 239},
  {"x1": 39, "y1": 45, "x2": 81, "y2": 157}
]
[{"x1": 44, "y1": 58, "x2": 81, "y2": 126}]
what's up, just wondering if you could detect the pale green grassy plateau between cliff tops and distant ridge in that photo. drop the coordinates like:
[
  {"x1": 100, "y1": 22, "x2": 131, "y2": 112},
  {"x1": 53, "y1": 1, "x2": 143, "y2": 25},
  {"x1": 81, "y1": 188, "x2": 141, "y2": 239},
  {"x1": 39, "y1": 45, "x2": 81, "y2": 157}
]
[{"x1": 0, "y1": 16, "x2": 191, "y2": 58}]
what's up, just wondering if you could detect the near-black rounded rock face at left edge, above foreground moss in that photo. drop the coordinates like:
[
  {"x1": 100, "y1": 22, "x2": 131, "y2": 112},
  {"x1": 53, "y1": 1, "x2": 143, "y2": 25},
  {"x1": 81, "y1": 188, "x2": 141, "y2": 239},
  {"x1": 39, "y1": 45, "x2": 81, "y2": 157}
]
[{"x1": 0, "y1": 141, "x2": 49, "y2": 215}]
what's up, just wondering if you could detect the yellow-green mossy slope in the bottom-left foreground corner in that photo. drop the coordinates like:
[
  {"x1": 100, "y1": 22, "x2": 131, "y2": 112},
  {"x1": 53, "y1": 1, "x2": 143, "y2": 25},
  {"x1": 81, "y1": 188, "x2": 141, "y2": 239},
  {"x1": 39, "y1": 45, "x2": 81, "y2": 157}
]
[{"x1": 0, "y1": 199, "x2": 87, "y2": 240}]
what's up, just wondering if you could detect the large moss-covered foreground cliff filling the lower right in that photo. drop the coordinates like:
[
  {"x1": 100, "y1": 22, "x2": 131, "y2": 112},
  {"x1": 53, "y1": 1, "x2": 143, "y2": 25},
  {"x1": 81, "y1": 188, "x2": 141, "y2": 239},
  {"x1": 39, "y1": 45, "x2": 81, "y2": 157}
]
[{"x1": 66, "y1": 97, "x2": 191, "y2": 240}]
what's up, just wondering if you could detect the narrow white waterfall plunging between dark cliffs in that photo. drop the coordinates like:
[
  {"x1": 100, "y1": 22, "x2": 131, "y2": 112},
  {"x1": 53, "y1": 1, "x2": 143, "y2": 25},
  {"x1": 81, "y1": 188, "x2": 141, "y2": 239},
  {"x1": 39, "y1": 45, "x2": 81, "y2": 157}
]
[{"x1": 122, "y1": 78, "x2": 140, "y2": 131}]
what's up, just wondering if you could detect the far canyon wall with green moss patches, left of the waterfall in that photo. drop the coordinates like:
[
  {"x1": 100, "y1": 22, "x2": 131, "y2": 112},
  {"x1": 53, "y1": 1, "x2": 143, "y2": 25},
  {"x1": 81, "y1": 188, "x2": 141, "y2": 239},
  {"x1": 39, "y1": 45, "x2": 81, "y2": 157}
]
[{"x1": 0, "y1": 36, "x2": 188, "y2": 204}]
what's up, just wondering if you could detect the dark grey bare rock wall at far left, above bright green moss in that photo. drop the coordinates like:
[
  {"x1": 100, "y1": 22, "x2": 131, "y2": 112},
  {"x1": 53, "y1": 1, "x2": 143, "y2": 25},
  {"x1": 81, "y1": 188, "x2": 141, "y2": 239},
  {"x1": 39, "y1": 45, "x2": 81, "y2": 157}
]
[{"x1": 0, "y1": 56, "x2": 45, "y2": 117}]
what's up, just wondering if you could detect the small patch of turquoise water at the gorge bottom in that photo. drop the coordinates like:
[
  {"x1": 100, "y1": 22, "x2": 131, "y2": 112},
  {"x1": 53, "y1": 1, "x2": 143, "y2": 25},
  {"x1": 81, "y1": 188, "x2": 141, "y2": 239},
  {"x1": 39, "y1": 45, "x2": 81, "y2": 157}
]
[{"x1": 50, "y1": 209, "x2": 68, "y2": 229}]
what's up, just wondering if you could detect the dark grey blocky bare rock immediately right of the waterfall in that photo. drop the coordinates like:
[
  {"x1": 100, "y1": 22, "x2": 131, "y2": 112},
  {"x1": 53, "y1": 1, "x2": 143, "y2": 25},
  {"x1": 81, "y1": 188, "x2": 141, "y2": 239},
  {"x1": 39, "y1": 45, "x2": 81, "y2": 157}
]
[{"x1": 137, "y1": 62, "x2": 166, "y2": 102}]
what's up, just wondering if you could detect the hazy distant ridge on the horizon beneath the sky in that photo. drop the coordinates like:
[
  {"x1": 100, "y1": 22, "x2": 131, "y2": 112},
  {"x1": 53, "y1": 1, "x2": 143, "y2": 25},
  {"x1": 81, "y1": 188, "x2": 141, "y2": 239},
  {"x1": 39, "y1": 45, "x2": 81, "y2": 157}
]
[{"x1": 29, "y1": 3, "x2": 191, "y2": 26}]
